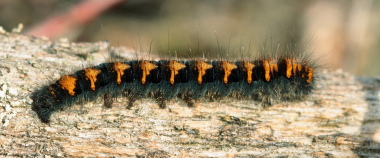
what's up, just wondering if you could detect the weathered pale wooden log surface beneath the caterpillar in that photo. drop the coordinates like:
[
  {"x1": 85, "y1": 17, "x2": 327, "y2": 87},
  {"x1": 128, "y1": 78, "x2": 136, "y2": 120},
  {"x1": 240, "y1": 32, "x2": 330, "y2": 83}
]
[{"x1": 0, "y1": 31, "x2": 380, "y2": 157}]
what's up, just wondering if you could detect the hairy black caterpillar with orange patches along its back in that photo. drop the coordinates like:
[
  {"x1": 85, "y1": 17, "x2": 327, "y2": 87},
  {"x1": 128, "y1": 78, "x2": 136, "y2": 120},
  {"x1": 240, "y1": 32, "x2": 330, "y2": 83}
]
[{"x1": 31, "y1": 53, "x2": 315, "y2": 123}]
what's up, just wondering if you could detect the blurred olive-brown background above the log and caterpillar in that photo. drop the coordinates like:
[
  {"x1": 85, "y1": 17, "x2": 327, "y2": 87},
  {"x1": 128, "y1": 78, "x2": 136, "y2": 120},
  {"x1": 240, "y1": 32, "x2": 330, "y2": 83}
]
[{"x1": 0, "y1": 0, "x2": 380, "y2": 76}]
